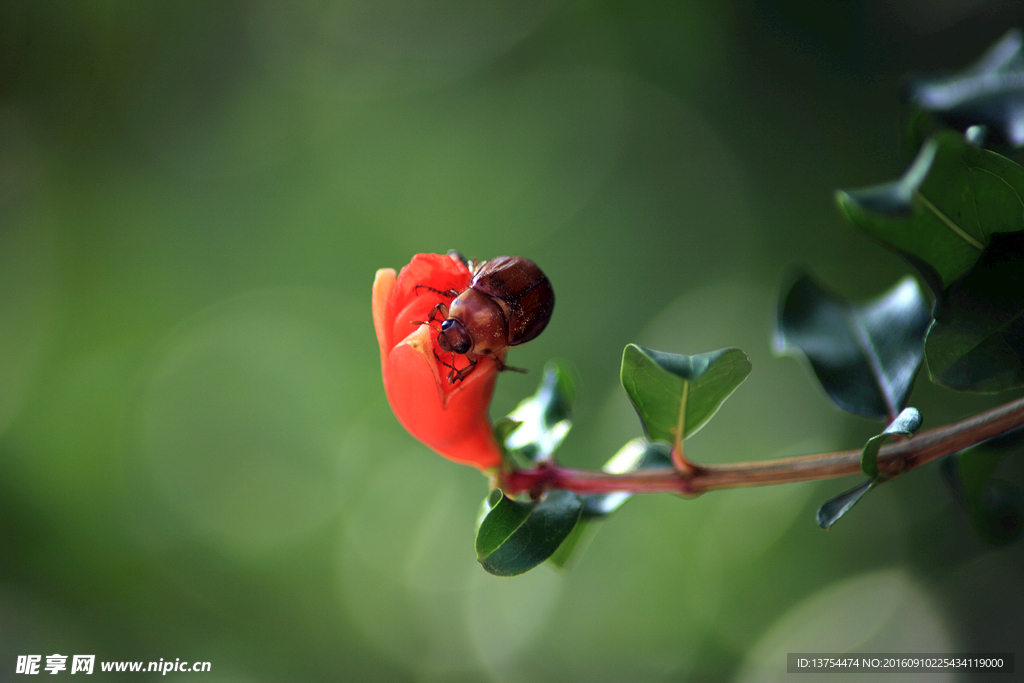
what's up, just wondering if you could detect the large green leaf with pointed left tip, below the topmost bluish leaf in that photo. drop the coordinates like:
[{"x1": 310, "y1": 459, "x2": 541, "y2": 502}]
[{"x1": 836, "y1": 131, "x2": 1024, "y2": 296}]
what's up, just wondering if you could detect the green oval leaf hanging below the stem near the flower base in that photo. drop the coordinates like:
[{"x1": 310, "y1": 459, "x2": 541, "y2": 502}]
[{"x1": 476, "y1": 488, "x2": 583, "y2": 577}]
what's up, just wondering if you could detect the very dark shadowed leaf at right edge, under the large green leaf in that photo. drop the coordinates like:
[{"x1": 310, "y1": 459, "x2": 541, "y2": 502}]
[{"x1": 925, "y1": 232, "x2": 1024, "y2": 391}]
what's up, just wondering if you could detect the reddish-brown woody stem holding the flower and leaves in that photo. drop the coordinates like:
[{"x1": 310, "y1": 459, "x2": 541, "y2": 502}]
[{"x1": 499, "y1": 398, "x2": 1024, "y2": 496}]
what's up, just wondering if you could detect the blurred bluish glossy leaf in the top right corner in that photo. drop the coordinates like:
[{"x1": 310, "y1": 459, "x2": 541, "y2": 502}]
[{"x1": 903, "y1": 29, "x2": 1024, "y2": 146}]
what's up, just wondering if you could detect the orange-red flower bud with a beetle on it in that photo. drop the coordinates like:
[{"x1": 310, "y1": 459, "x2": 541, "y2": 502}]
[{"x1": 373, "y1": 254, "x2": 502, "y2": 470}]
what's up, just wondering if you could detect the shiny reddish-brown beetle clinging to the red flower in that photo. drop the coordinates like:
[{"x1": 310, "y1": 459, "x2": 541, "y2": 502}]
[{"x1": 417, "y1": 252, "x2": 555, "y2": 384}]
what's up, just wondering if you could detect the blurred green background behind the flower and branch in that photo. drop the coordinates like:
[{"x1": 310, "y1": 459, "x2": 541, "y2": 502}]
[{"x1": 0, "y1": 0, "x2": 1024, "y2": 683}]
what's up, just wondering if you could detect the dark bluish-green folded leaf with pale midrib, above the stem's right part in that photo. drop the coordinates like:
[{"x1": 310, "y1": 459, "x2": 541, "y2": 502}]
[{"x1": 775, "y1": 274, "x2": 932, "y2": 420}]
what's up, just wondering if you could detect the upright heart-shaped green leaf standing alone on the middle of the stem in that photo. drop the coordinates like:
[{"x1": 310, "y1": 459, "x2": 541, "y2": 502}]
[{"x1": 622, "y1": 344, "x2": 751, "y2": 444}]
